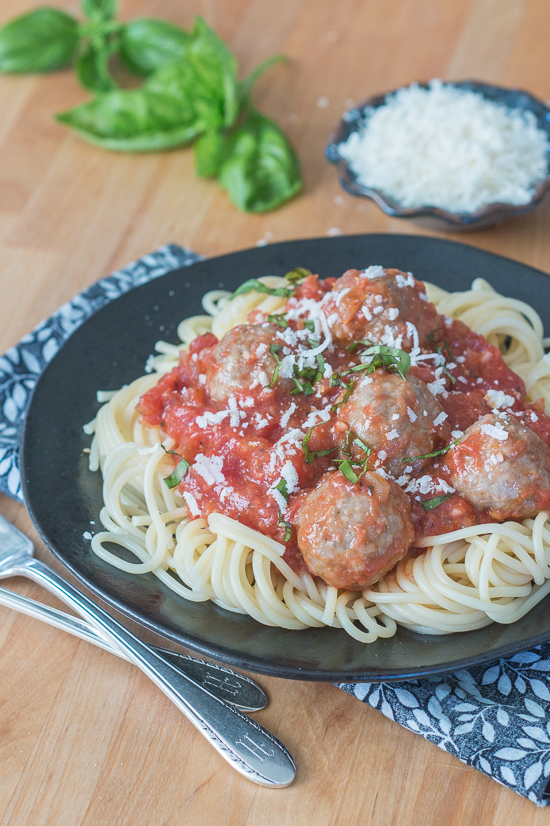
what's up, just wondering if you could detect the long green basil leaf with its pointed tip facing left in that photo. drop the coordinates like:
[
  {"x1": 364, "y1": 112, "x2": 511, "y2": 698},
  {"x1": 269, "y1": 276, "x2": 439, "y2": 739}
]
[{"x1": 57, "y1": 83, "x2": 204, "y2": 152}]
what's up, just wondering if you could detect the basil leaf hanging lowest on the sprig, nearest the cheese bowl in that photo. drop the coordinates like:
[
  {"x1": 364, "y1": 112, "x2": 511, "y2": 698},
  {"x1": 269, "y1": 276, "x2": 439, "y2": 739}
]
[{"x1": 219, "y1": 111, "x2": 302, "y2": 212}]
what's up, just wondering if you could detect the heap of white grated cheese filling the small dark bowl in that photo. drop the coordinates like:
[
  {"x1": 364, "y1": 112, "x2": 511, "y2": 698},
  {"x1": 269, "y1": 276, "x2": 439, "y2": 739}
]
[{"x1": 338, "y1": 80, "x2": 548, "y2": 213}]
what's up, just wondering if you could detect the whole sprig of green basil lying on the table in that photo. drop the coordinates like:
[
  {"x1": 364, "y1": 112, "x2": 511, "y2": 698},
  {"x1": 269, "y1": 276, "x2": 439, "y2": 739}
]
[{"x1": 0, "y1": 0, "x2": 302, "y2": 212}]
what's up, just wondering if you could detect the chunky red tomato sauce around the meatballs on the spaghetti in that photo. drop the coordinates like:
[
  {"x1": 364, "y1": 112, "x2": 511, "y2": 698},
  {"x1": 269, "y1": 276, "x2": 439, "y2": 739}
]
[{"x1": 138, "y1": 276, "x2": 550, "y2": 570}]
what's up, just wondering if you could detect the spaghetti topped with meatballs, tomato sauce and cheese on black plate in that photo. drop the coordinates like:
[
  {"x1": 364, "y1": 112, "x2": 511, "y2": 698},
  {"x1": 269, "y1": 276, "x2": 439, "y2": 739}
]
[{"x1": 87, "y1": 266, "x2": 550, "y2": 642}]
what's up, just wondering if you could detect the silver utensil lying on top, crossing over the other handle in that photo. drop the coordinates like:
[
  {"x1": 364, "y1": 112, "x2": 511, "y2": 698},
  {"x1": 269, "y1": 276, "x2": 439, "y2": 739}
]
[{"x1": 0, "y1": 516, "x2": 296, "y2": 788}]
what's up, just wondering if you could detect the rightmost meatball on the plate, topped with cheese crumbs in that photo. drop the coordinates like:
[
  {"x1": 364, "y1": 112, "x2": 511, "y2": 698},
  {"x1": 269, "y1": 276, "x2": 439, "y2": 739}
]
[{"x1": 444, "y1": 414, "x2": 550, "y2": 520}]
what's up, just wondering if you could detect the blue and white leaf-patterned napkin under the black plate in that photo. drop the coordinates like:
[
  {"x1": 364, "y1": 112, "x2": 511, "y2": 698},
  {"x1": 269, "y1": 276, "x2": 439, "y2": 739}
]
[{"x1": 4, "y1": 244, "x2": 550, "y2": 806}]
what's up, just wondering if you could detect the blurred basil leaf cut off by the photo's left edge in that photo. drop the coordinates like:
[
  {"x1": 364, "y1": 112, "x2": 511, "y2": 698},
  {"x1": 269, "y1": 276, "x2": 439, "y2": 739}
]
[{"x1": 0, "y1": 8, "x2": 79, "y2": 74}]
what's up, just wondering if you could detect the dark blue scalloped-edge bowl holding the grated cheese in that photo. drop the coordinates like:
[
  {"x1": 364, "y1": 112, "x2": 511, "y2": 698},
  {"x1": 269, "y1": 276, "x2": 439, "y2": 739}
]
[{"x1": 325, "y1": 80, "x2": 550, "y2": 231}]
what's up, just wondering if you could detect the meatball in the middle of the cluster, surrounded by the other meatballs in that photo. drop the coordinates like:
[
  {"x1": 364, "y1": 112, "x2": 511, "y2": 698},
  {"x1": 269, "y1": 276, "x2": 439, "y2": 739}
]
[{"x1": 336, "y1": 369, "x2": 451, "y2": 478}]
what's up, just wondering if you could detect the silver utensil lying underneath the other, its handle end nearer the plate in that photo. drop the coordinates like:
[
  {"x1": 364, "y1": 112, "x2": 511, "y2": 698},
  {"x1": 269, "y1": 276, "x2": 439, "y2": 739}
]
[{"x1": 0, "y1": 588, "x2": 267, "y2": 712}]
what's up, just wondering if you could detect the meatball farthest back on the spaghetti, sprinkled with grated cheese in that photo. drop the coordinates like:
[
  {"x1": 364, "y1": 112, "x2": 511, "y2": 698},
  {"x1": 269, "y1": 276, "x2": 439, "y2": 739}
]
[{"x1": 323, "y1": 267, "x2": 439, "y2": 352}]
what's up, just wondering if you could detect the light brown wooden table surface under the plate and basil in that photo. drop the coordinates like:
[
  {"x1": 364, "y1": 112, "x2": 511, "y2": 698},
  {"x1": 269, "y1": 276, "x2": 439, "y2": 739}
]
[{"x1": 0, "y1": 0, "x2": 550, "y2": 826}]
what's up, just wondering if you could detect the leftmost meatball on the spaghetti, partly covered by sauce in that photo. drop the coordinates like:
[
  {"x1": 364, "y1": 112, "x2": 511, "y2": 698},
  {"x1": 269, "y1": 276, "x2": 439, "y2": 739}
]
[{"x1": 206, "y1": 324, "x2": 292, "y2": 402}]
